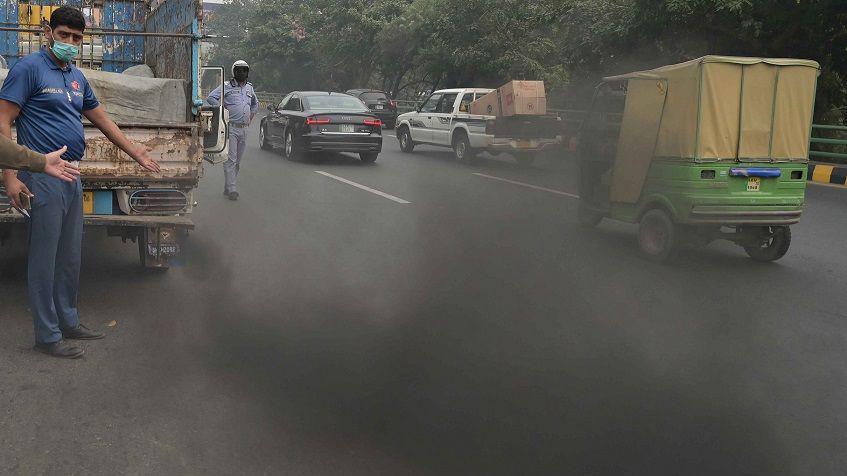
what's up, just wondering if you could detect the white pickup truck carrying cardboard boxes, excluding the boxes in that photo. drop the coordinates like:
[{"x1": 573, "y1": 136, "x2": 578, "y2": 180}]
[{"x1": 396, "y1": 88, "x2": 562, "y2": 164}]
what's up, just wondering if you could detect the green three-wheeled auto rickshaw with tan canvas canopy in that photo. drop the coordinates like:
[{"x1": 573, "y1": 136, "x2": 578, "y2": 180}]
[{"x1": 578, "y1": 56, "x2": 820, "y2": 261}]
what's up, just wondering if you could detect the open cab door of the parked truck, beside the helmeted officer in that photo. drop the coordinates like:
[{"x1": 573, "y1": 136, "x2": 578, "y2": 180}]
[{"x1": 200, "y1": 66, "x2": 229, "y2": 164}]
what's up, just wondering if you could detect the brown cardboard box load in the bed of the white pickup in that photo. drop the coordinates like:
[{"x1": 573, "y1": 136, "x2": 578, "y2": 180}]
[{"x1": 471, "y1": 81, "x2": 547, "y2": 117}]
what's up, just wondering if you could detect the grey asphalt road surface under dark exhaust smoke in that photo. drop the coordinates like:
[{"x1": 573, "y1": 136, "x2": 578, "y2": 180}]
[{"x1": 0, "y1": 127, "x2": 847, "y2": 475}]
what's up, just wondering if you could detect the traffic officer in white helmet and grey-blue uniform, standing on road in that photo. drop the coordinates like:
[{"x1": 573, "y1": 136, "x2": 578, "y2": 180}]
[{"x1": 206, "y1": 60, "x2": 259, "y2": 200}]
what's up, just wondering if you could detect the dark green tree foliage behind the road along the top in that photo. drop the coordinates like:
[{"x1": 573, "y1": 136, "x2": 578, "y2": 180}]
[{"x1": 210, "y1": 0, "x2": 847, "y2": 116}]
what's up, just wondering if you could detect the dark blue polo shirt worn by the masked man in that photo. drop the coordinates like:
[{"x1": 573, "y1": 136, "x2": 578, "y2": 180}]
[{"x1": 0, "y1": 48, "x2": 100, "y2": 160}]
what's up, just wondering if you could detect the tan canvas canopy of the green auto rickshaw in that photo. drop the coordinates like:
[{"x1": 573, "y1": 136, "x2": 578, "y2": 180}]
[{"x1": 604, "y1": 56, "x2": 820, "y2": 203}]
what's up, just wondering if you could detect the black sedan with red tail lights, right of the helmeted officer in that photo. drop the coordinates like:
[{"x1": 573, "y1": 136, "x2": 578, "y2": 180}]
[{"x1": 259, "y1": 91, "x2": 382, "y2": 162}]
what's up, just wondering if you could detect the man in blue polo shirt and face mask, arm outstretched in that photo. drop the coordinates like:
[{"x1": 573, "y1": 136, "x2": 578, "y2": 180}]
[{"x1": 0, "y1": 7, "x2": 159, "y2": 358}]
